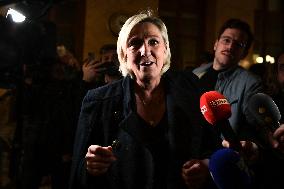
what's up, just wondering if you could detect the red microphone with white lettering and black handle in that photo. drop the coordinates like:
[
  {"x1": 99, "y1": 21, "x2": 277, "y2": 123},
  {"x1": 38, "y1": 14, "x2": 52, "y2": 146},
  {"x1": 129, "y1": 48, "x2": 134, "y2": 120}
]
[{"x1": 200, "y1": 91, "x2": 241, "y2": 151}]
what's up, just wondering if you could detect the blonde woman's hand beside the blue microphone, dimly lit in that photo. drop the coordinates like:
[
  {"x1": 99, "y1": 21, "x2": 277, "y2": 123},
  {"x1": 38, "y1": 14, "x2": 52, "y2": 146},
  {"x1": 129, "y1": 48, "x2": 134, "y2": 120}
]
[{"x1": 181, "y1": 159, "x2": 210, "y2": 189}]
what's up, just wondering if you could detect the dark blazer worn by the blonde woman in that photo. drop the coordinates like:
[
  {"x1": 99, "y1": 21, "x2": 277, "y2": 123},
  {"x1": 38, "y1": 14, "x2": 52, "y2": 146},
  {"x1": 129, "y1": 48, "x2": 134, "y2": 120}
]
[{"x1": 70, "y1": 72, "x2": 220, "y2": 189}]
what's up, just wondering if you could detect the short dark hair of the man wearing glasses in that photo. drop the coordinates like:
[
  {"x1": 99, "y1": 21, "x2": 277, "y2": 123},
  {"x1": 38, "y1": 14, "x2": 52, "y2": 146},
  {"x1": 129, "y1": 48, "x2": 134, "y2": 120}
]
[{"x1": 218, "y1": 18, "x2": 254, "y2": 55}]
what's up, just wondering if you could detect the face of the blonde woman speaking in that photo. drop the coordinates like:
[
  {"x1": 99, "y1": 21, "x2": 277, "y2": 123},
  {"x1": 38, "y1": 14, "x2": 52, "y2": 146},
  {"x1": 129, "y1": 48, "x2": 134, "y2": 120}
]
[{"x1": 126, "y1": 22, "x2": 166, "y2": 82}]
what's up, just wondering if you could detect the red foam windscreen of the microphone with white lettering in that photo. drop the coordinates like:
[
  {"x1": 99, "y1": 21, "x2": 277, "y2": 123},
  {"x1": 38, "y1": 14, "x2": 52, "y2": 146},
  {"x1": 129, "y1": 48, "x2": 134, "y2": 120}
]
[{"x1": 200, "y1": 91, "x2": 232, "y2": 125}]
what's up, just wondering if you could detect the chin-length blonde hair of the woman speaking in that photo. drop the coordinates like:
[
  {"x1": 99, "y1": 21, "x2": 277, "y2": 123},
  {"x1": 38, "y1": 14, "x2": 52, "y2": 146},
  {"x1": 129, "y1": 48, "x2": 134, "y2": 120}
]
[{"x1": 117, "y1": 10, "x2": 171, "y2": 78}]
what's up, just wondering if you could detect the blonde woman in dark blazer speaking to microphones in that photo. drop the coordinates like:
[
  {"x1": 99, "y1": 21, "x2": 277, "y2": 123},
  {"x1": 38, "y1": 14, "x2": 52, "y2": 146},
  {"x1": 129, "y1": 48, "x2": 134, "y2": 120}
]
[{"x1": 70, "y1": 10, "x2": 220, "y2": 189}]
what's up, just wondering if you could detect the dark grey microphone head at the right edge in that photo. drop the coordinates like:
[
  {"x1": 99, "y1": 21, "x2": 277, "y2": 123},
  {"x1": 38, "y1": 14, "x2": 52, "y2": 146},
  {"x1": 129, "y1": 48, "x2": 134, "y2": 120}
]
[{"x1": 248, "y1": 93, "x2": 281, "y2": 132}]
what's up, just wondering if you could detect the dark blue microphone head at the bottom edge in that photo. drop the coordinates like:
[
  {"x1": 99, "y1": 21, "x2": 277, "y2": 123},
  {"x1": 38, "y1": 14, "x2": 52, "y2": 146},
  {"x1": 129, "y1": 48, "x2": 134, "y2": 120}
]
[{"x1": 209, "y1": 148, "x2": 252, "y2": 189}]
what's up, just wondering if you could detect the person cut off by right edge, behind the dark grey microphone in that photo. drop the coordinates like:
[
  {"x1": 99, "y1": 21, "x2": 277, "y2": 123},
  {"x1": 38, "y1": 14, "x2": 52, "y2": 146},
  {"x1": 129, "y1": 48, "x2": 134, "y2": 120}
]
[{"x1": 252, "y1": 52, "x2": 284, "y2": 188}]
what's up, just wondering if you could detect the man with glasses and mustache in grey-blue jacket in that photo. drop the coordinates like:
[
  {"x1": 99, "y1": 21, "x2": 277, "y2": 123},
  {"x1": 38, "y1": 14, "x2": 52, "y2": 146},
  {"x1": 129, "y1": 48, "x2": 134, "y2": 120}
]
[{"x1": 193, "y1": 18, "x2": 263, "y2": 159}]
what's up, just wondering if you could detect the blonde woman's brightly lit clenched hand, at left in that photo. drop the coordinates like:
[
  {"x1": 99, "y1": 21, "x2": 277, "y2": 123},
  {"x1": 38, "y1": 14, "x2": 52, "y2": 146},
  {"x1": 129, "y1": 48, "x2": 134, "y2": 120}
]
[{"x1": 85, "y1": 145, "x2": 116, "y2": 176}]
